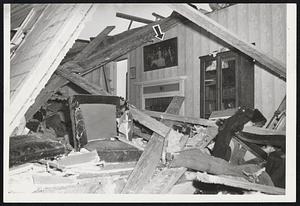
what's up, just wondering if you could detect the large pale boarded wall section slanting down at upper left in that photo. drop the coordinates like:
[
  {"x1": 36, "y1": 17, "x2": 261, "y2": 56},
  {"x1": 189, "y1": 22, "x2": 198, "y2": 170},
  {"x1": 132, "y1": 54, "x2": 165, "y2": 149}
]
[{"x1": 9, "y1": 4, "x2": 93, "y2": 134}]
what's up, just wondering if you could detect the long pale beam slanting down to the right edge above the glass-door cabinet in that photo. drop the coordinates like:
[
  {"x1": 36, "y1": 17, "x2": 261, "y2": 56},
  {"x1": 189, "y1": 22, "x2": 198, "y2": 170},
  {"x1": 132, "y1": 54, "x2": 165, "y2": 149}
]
[{"x1": 169, "y1": 4, "x2": 286, "y2": 81}]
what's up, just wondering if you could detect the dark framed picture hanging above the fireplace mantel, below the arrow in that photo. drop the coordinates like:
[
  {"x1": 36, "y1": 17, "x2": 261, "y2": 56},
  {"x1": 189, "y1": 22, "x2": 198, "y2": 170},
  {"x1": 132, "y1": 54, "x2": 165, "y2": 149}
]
[{"x1": 144, "y1": 37, "x2": 178, "y2": 72}]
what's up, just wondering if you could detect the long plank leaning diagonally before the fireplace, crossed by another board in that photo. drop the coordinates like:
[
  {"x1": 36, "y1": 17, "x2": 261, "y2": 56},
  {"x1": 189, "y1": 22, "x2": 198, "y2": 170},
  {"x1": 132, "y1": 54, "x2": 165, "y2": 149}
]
[{"x1": 122, "y1": 97, "x2": 184, "y2": 194}]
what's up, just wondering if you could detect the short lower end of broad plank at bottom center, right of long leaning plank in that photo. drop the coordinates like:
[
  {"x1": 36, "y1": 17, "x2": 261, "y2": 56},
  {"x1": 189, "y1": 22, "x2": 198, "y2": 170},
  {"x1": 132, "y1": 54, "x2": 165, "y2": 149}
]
[{"x1": 140, "y1": 167, "x2": 187, "y2": 194}]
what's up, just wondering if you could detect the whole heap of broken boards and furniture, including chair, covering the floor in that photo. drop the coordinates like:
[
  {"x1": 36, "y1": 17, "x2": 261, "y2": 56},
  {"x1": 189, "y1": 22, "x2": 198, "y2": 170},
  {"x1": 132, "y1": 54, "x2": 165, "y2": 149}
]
[{"x1": 9, "y1": 94, "x2": 285, "y2": 195}]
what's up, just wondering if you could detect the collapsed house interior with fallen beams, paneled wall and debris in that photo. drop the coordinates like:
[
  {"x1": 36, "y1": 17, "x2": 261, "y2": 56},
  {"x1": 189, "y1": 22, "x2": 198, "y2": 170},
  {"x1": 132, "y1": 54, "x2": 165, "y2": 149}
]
[{"x1": 5, "y1": 4, "x2": 287, "y2": 195}]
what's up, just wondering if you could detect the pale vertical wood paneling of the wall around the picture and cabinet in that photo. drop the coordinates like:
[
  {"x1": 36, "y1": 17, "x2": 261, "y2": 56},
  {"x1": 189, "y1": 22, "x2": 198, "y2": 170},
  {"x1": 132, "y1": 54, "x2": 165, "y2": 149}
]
[{"x1": 128, "y1": 4, "x2": 286, "y2": 119}]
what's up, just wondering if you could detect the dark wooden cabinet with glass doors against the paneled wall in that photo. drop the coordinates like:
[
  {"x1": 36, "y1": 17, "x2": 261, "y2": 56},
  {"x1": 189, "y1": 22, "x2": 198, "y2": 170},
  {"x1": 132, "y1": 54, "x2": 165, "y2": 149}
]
[{"x1": 200, "y1": 51, "x2": 254, "y2": 118}]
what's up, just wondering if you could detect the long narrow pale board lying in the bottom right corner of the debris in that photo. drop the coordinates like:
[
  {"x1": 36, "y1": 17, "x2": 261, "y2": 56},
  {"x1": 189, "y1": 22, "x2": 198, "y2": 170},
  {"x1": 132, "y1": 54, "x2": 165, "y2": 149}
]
[{"x1": 190, "y1": 172, "x2": 285, "y2": 195}]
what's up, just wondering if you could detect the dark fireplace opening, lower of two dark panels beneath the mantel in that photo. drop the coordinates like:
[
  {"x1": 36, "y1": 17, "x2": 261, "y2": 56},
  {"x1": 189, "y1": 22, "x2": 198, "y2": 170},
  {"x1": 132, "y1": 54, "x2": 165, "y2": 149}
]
[{"x1": 145, "y1": 97, "x2": 173, "y2": 112}]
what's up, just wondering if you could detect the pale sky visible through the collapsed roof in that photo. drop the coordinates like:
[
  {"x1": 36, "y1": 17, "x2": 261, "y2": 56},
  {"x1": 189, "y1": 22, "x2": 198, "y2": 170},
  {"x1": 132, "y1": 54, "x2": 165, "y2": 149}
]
[{"x1": 78, "y1": 3, "x2": 211, "y2": 40}]
